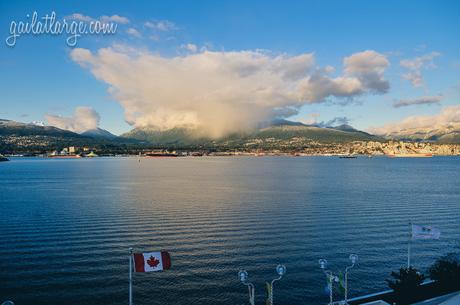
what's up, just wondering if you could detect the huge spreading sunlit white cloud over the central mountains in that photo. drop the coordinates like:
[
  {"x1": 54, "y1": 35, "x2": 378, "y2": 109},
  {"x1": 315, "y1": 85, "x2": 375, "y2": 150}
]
[{"x1": 71, "y1": 47, "x2": 388, "y2": 137}]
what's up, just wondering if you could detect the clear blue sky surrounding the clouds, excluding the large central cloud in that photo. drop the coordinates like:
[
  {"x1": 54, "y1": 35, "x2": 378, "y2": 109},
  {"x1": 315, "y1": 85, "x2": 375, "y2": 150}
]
[{"x1": 0, "y1": 1, "x2": 460, "y2": 134}]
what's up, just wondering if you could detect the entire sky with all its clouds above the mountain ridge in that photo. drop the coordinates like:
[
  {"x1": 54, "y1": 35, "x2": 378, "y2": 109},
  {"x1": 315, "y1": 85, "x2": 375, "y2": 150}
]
[{"x1": 0, "y1": 0, "x2": 460, "y2": 137}]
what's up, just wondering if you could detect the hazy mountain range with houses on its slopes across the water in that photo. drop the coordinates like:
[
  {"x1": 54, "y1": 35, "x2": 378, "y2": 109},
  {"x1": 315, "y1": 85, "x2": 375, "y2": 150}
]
[{"x1": 0, "y1": 119, "x2": 460, "y2": 151}]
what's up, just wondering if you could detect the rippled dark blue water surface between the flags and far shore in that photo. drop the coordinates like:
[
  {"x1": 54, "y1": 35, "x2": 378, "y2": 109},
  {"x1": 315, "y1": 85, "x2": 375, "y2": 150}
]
[{"x1": 0, "y1": 157, "x2": 460, "y2": 305}]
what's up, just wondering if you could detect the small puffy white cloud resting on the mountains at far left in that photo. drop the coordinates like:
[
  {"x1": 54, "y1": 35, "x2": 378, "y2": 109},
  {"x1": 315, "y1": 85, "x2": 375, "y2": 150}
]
[{"x1": 45, "y1": 107, "x2": 100, "y2": 133}]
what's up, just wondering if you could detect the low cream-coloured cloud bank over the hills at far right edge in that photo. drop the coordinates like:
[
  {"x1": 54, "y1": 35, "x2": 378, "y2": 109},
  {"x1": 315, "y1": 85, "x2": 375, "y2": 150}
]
[{"x1": 369, "y1": 105, "x2": 460, "y2": 136}]
